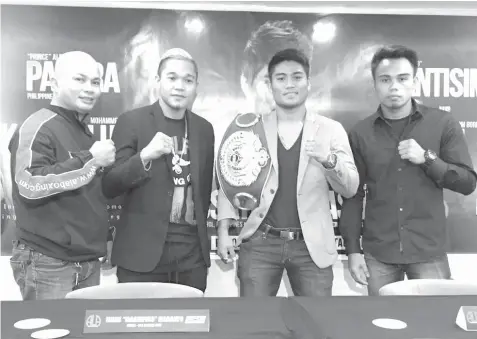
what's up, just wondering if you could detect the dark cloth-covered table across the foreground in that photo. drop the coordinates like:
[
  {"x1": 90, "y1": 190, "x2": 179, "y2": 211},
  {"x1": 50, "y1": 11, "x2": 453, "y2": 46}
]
[{"x1": 1, "y1": 296, "x2": 477, "y2": 339}]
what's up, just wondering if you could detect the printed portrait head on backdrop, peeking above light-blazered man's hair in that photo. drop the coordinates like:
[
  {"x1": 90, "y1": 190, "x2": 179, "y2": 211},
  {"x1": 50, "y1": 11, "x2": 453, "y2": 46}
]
[{"x1": 242, "y1": 20, "x2": 313, "y2": 85}]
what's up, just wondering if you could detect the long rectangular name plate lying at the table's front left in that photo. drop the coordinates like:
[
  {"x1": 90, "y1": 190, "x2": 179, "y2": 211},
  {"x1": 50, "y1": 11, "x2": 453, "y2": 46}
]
[{"x1": 83, "y1": 309, "x2": 210, "y2": 333}]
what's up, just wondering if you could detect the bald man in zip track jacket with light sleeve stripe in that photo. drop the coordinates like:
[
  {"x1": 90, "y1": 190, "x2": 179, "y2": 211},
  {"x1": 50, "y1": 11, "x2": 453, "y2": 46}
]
[{"x1": 10, "y1": 51, "x2": 115, "y2": 300}]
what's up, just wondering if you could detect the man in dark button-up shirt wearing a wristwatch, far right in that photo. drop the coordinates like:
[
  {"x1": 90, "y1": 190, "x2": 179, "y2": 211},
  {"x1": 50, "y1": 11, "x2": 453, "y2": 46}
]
[{"x1": 339, "y1": 46, "x2": 477, "y2": 295}]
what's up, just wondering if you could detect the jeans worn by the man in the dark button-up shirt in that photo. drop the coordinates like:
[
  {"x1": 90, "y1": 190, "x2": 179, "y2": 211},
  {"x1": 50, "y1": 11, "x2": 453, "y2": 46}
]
[{"x1": 364, "y1": 252, "x2": 451, "y2": 296}]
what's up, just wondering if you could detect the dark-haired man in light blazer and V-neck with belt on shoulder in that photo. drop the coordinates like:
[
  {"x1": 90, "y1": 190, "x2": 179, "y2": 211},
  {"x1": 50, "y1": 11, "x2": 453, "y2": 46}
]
[{"x1": 217, "y1": 48, "x2": 359, "y2": 296}]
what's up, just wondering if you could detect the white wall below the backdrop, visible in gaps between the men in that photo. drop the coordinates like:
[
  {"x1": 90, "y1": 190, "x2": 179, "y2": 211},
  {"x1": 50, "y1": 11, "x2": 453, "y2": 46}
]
[{"x1": 0, "y1": 254, "x2": 477, "y2": 300}]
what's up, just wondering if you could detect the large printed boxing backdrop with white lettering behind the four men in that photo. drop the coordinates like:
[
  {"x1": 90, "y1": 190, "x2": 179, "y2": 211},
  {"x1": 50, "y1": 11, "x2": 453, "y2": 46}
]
[{"x1": 0, "y1": 5, "x2": 477, "y2": 258}]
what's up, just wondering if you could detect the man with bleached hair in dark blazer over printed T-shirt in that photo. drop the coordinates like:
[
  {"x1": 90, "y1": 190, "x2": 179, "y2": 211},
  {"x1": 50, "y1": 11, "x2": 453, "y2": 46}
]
[{"x1": 103, "y1": 49, "x2": 214, "y2": 291}]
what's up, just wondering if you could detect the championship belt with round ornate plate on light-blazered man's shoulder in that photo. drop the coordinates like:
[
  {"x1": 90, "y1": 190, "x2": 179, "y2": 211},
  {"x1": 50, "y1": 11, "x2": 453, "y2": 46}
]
[{"x1": 217, "y1": 113, "x2": 272, "y2": 211}]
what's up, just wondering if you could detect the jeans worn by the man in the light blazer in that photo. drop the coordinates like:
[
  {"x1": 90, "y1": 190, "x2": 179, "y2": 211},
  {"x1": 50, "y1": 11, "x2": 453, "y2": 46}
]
[{"x1": 237, "y1": 230, "x2": 333, "y2": 297}]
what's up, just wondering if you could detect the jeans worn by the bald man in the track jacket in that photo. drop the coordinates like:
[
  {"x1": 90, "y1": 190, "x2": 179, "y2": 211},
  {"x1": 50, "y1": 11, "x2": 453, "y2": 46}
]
[{"x1": 10, "y1": 241, "x2": 101, "y2": 300}]
